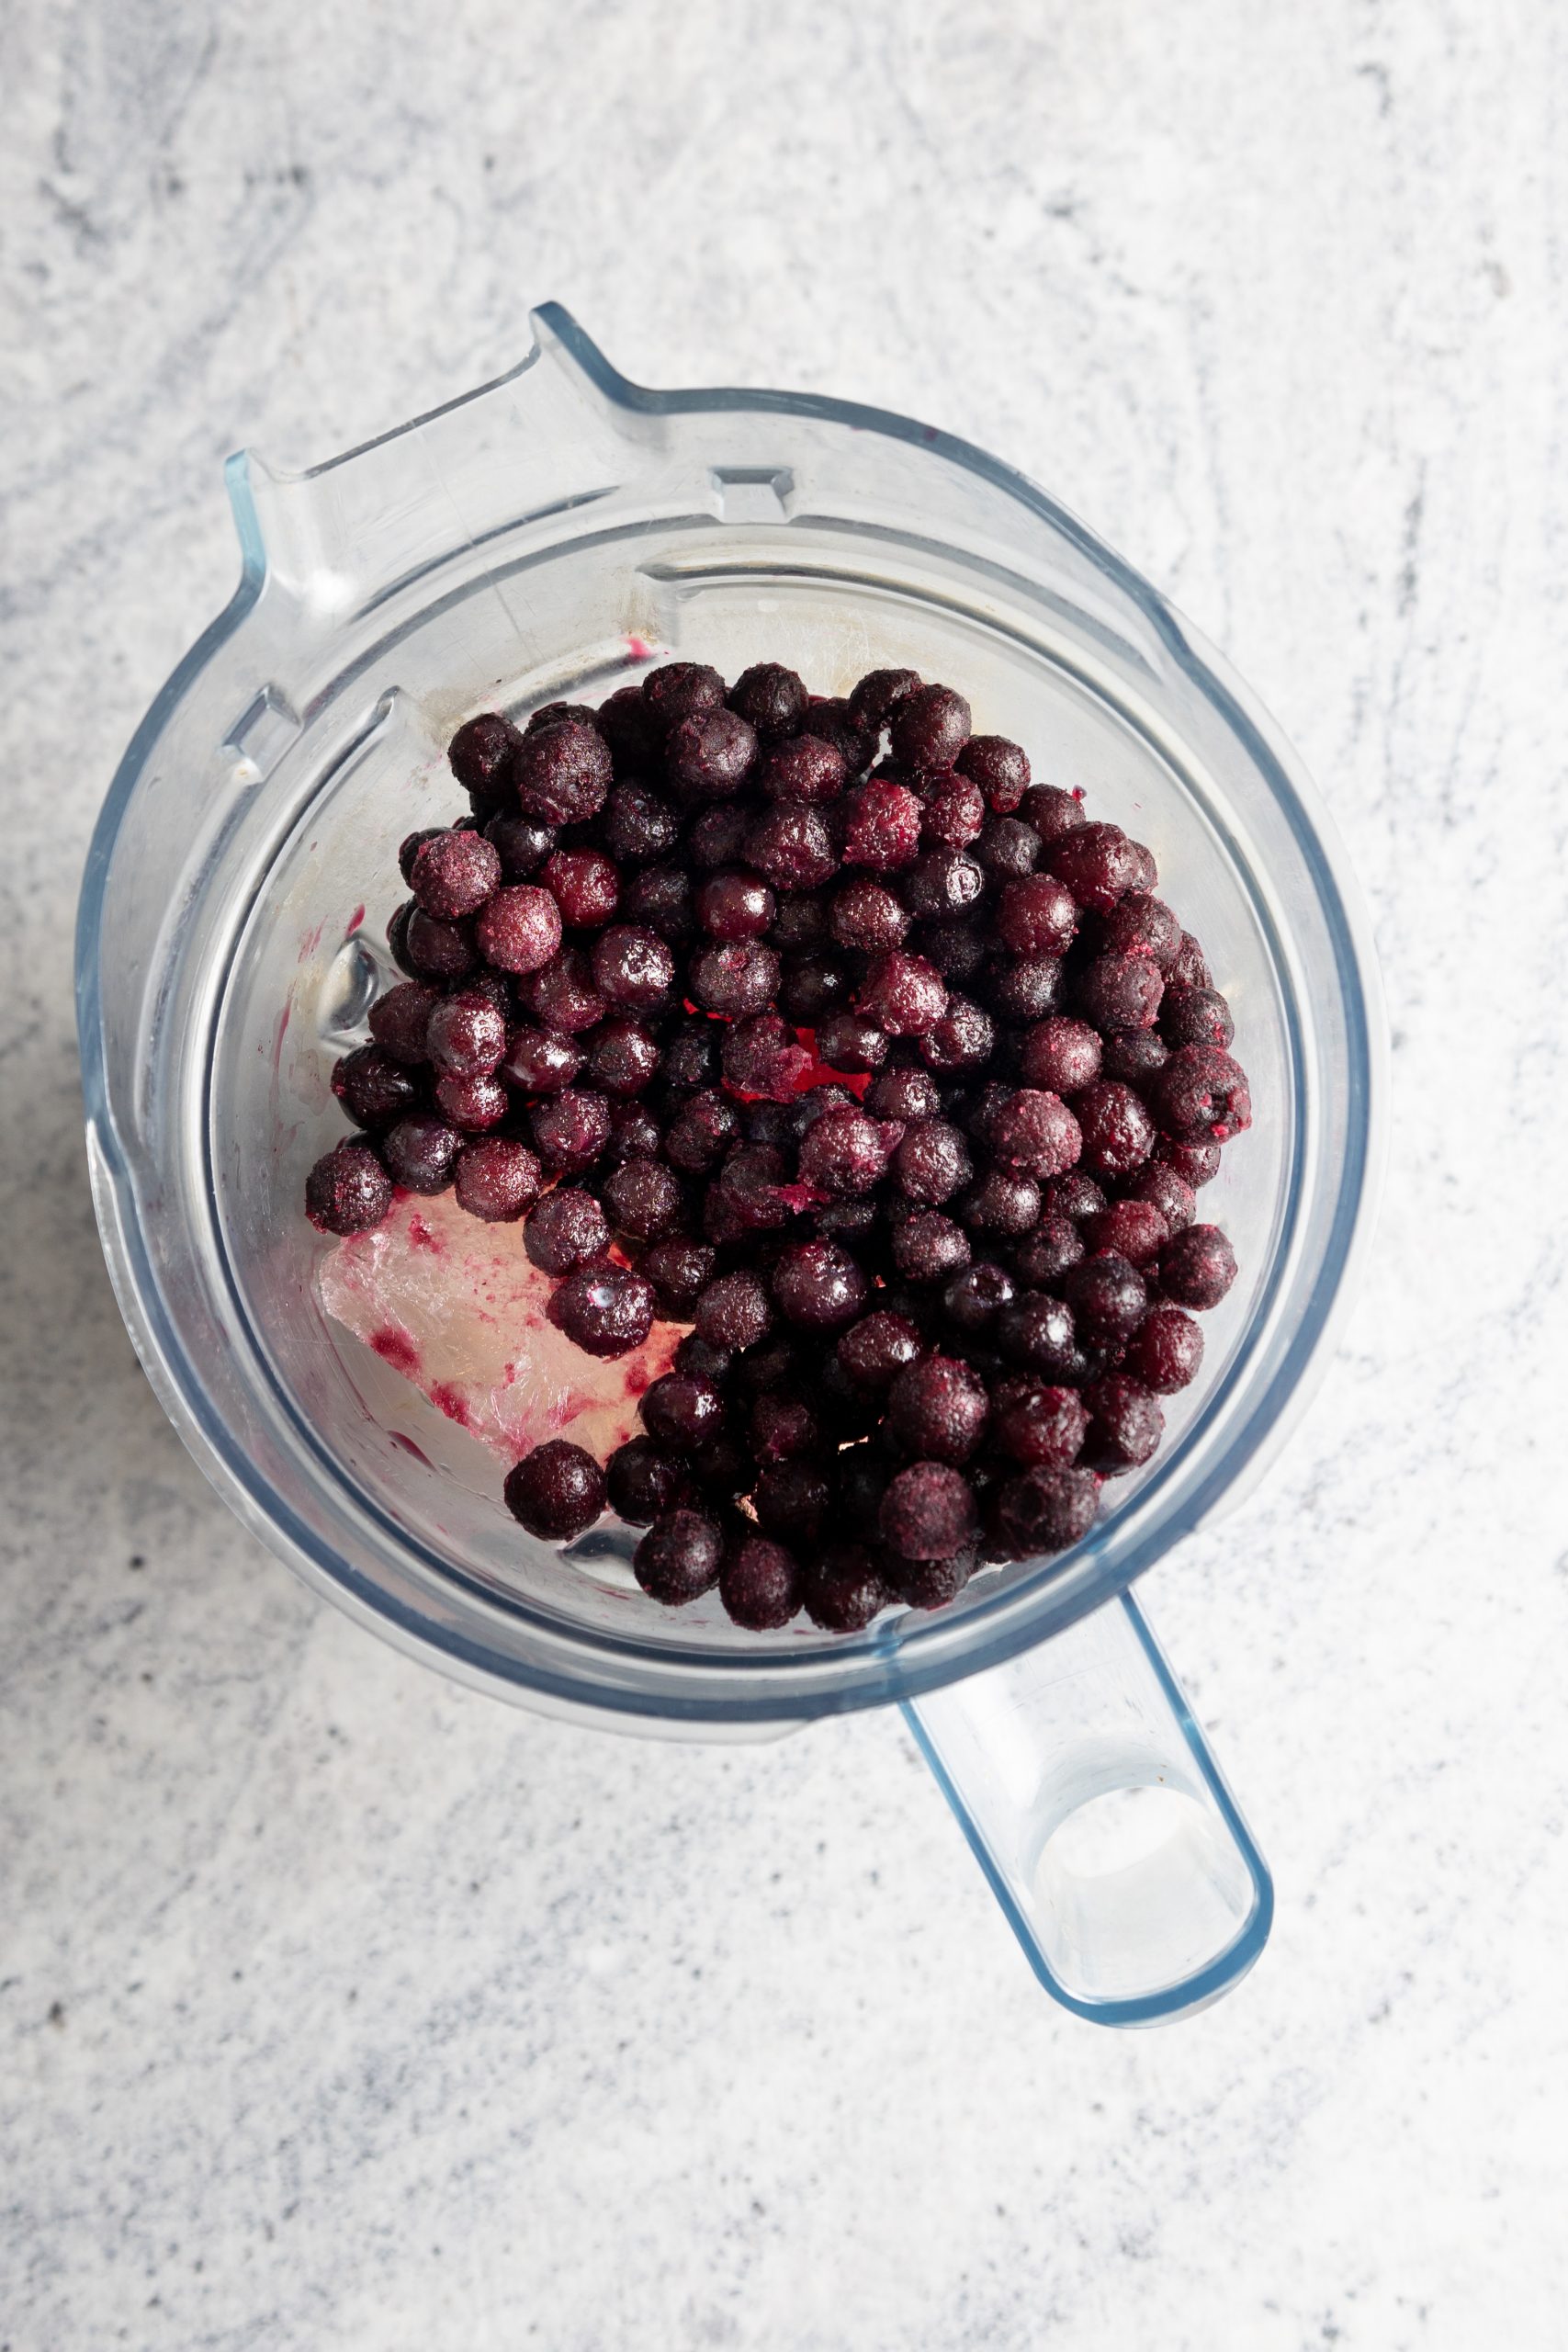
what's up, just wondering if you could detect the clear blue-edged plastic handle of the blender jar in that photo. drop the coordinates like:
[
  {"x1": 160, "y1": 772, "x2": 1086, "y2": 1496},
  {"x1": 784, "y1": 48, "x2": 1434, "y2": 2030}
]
[{"x1": 903, "y1": 1592, "x2": 1274, "y2": 2025}]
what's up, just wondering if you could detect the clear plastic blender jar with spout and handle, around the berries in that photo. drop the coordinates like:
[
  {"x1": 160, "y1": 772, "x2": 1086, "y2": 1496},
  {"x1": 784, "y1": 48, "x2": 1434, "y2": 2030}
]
[{"x1": 77, "y1": 308, "x2": 1380, "y2": 2025}]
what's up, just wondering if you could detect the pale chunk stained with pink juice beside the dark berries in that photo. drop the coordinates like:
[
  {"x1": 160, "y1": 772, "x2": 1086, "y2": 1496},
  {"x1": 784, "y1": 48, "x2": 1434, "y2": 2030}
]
[{"x1": 315, "y1": 1193, "x2": 686, "y2": 1463}]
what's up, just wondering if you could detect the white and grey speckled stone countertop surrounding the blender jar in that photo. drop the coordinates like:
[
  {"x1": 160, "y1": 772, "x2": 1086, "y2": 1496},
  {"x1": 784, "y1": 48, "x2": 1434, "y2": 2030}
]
[{"x1": 0, "y1": 0, "x2": 1568, "y2": 2352}]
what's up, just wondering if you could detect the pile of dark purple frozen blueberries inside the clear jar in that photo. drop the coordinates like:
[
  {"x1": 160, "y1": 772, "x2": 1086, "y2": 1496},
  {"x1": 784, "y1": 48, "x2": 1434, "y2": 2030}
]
[{"x1": 306, "y1": 661, "x2": 1251, "y2": 1633}]
